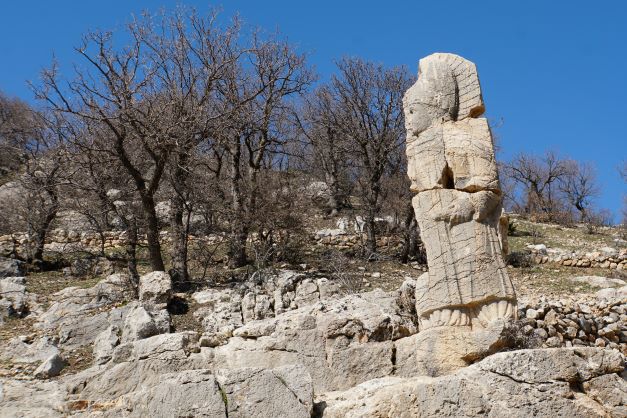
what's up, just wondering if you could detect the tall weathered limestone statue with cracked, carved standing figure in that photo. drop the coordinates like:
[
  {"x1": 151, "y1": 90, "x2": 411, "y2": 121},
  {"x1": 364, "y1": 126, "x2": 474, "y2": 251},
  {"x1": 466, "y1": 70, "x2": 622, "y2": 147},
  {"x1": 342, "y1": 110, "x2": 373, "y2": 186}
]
[{"x1": 403, "y1": 53, "x2": 516, "y2": 330}]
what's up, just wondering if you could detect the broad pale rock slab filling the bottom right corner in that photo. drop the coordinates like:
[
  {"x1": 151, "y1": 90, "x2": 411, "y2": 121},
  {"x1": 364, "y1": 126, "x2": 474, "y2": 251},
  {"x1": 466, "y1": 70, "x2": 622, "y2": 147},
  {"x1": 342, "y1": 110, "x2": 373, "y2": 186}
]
[{"x1": 317, "y1": 348, "x2": 627, "y2": 417}]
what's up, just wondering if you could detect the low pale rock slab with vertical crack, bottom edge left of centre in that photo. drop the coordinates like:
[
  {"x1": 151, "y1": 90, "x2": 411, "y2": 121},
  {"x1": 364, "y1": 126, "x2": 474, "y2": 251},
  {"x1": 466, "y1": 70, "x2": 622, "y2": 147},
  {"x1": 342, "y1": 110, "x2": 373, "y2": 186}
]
[{"x1": 65, "y1": 366, "x2": 313, "y2": 417}]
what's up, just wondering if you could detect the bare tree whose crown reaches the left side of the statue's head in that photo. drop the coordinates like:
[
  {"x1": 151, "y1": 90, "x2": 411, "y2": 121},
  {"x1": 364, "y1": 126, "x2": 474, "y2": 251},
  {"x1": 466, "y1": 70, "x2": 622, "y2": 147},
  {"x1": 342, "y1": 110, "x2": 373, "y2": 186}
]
[{"x1": 330, "y1": 58, "x2": 413, "y2": 257}]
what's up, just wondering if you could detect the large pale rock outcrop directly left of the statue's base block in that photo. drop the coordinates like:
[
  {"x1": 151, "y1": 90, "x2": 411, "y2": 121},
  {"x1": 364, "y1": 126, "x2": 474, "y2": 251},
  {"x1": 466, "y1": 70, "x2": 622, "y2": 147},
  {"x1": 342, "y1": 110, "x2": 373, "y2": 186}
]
[{"x1": 214, "y1": 290, "x2": 417, "y2": 391}]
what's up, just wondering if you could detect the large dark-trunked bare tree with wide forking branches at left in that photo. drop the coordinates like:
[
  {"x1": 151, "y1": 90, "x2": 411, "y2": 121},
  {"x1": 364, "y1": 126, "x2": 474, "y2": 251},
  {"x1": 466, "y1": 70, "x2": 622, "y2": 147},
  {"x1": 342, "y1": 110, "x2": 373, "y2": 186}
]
[{"x1": 37, "y1": 13, "x2": 205, "y2": 271}]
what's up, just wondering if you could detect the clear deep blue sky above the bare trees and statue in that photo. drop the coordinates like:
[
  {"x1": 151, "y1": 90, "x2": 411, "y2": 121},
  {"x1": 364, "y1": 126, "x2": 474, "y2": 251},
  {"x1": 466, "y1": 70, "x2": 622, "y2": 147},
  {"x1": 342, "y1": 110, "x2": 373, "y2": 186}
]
[{"x1": 0, "y1": 0, "x2": 627, "y2": 213}]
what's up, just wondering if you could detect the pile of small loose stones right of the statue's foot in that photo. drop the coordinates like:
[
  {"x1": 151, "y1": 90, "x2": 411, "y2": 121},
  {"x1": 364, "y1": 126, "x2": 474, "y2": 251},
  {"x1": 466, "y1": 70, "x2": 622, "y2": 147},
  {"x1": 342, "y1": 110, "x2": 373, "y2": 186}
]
[{"x1": 519, "y1": 299, "x2": 627, "y2": 355}]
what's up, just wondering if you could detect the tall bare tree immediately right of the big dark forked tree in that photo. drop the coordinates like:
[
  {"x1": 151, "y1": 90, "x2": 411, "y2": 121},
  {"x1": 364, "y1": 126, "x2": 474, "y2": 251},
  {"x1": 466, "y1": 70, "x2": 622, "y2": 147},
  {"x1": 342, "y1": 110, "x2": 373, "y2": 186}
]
[{"x1": 131, "y1": 10, "x2": 242, "y2": 283}]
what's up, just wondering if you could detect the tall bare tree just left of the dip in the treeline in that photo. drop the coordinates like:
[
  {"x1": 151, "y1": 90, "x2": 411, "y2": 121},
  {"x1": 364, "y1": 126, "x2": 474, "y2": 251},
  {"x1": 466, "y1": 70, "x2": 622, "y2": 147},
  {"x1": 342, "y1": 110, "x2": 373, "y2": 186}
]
[{"x1": 213, "y1": 34, "x2": 314, "y2": 267}]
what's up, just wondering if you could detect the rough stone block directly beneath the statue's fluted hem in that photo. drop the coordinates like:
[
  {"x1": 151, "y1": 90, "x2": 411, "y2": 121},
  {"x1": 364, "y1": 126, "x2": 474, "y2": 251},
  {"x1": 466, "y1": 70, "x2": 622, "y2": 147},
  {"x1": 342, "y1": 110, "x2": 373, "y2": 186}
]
[{"x1": 396, "y1": 319, "x2": 510, "y2": 377}]
